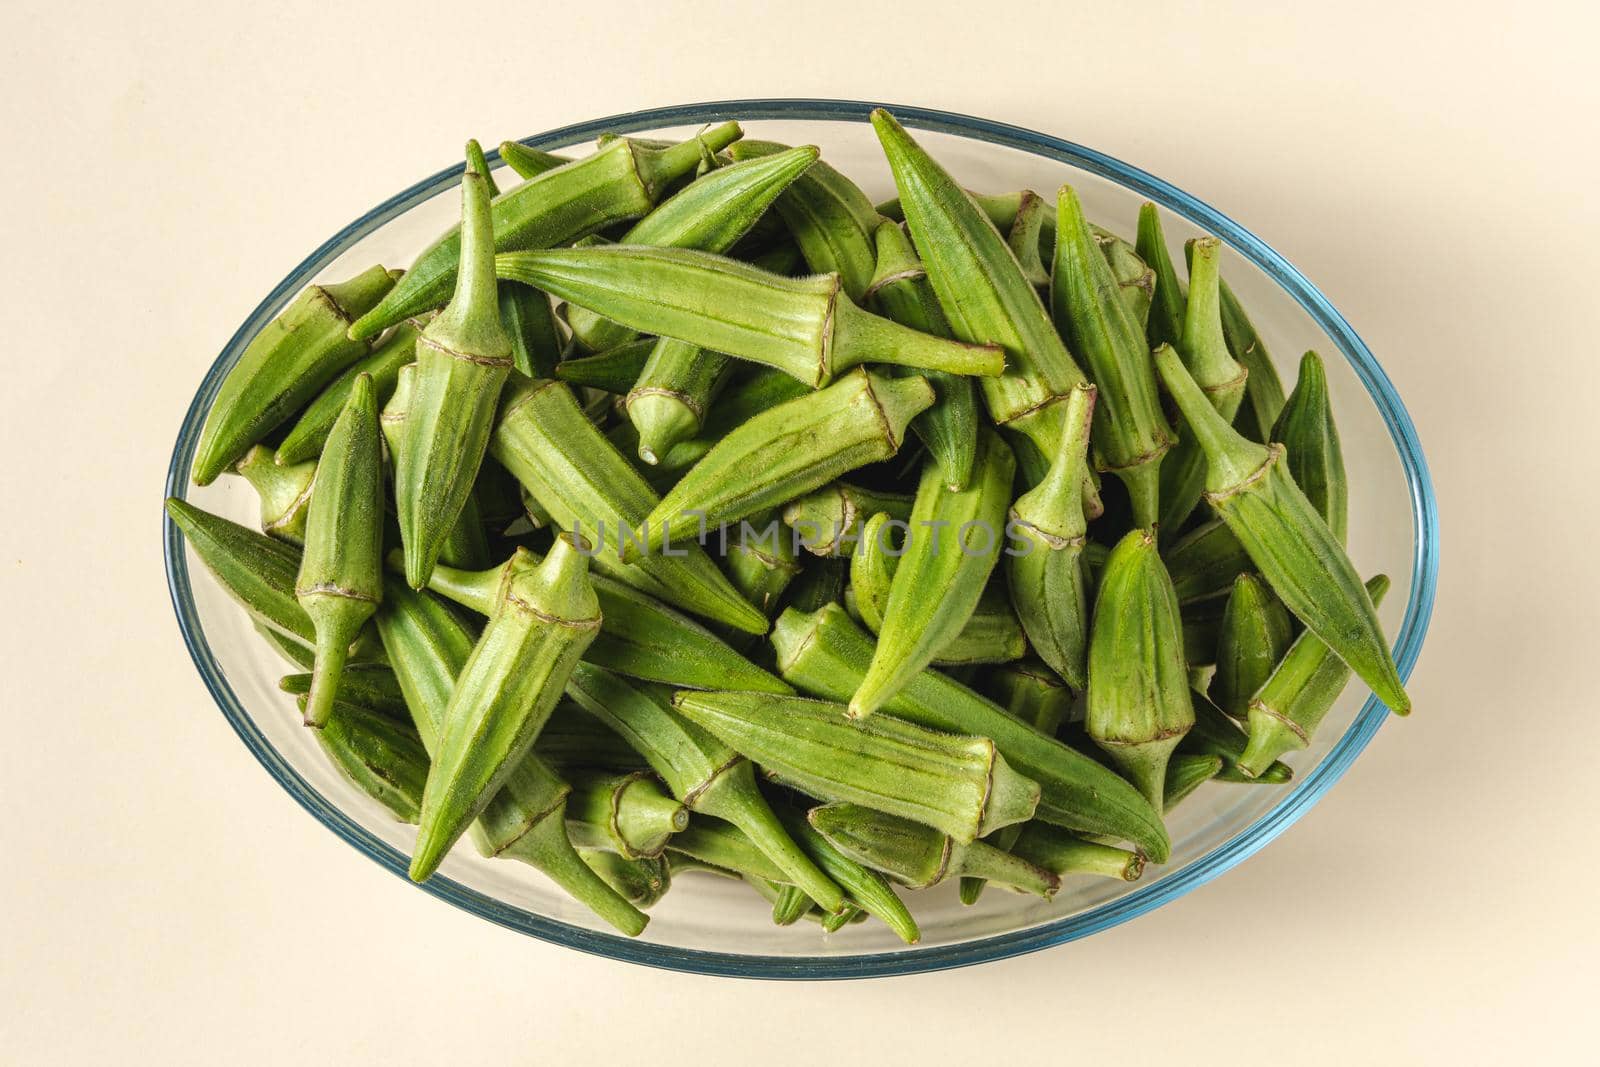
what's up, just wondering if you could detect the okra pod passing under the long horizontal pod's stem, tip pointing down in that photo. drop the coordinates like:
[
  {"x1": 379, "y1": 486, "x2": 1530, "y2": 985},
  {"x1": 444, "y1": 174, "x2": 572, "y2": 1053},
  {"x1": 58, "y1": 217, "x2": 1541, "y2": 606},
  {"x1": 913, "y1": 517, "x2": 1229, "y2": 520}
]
[{"x1": 866, "y1": 221, "x2": 982, "y2": 490}]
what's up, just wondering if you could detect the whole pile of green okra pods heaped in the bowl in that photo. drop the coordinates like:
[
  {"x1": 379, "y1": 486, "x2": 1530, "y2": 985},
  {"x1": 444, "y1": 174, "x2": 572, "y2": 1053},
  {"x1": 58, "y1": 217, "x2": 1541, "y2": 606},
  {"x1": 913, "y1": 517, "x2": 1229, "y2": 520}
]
[{"x1": 166, "y1": 110, "x2": 1410, "y2": 942}]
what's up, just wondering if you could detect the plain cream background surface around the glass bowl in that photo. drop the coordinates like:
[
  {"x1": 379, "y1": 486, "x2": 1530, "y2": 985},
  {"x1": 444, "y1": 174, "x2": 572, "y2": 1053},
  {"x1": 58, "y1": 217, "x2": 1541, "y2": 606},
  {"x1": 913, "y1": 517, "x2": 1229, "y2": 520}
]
[{"x1": 0, "y1": 0, "x2": 1600, "y2": 1064}]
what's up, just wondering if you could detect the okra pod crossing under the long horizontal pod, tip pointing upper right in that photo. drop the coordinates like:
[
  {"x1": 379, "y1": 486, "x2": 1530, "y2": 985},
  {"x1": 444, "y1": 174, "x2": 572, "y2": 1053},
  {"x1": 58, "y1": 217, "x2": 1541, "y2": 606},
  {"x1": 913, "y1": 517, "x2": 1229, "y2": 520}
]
[{"x1": 566, "y1": 146, "x2": 818, "y2": 350}]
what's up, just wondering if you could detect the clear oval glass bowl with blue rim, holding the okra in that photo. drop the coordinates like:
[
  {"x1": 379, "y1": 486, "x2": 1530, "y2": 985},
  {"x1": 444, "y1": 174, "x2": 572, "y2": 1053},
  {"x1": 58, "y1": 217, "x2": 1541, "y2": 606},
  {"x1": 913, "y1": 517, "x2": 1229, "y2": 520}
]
[{"x1": 163, "y1": 101, "x2": 1438, "y2": 979}]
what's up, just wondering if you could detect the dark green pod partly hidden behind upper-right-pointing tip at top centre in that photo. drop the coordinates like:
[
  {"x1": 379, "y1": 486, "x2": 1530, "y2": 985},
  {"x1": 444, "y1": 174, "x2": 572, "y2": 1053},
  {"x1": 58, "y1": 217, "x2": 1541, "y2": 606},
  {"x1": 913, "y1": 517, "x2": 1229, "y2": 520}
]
[{"x1": 728, "y1": 141, "x2": 878, "y2": 302}]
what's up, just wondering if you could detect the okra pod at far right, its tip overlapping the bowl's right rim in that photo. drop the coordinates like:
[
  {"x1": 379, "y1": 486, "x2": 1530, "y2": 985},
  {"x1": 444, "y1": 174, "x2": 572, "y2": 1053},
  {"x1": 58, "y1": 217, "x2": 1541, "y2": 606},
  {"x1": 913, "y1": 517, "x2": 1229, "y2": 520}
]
[{"x1": 1155, "y1": 346, "x2": 1411, "y2": 715}]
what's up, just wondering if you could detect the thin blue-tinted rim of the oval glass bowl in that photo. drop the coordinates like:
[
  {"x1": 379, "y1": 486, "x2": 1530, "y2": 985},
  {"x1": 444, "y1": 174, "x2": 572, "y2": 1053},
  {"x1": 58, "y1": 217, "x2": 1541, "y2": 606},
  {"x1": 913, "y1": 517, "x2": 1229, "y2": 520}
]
[{"x1": 162, "y1": 99, "x2": 1438, "y2": 979}]
